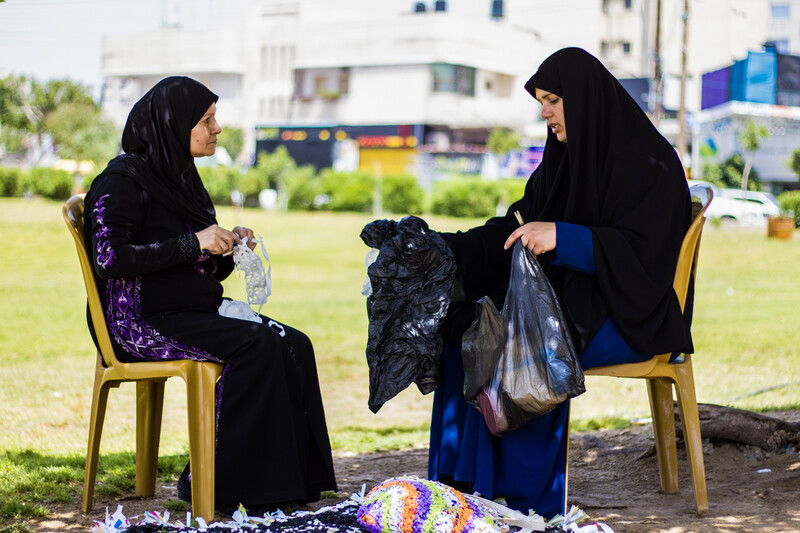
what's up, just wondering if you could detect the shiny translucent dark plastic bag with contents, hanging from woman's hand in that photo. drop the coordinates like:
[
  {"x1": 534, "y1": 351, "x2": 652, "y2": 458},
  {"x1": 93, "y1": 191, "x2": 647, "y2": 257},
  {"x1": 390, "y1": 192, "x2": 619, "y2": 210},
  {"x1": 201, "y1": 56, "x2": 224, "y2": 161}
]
[{"x1": 461, "y1": 241, "x2": 585, "y2": 435}]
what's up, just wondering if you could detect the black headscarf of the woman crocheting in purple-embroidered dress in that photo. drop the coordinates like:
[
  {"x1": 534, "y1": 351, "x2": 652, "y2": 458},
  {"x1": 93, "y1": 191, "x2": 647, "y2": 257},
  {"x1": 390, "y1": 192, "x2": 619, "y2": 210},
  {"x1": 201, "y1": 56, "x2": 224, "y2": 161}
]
[{"x1": 94, "y1": 76, "x2": 218, "y2": 230}]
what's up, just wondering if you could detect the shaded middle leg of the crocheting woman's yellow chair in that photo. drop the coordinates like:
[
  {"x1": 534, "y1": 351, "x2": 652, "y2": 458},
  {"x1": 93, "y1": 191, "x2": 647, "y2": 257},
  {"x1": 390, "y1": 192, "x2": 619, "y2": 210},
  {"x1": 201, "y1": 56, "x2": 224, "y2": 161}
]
[{"x1": 136, "y1": 380, "x2": 165, "y2": 497}]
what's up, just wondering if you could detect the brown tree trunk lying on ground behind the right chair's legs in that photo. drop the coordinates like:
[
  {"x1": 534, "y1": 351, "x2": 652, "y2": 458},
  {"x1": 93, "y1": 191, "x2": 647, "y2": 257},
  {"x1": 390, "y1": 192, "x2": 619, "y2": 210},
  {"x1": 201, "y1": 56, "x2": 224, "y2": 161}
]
[{"x1": 675, "y1": 404, "x2": 800, "y2": 451}]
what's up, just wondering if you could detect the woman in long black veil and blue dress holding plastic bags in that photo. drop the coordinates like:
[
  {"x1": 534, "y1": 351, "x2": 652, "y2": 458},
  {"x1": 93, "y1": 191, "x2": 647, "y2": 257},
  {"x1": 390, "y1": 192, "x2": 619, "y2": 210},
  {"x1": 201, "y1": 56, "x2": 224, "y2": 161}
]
[{"x1": 429, "y1": 48, "x2": 692, "y2": 516}]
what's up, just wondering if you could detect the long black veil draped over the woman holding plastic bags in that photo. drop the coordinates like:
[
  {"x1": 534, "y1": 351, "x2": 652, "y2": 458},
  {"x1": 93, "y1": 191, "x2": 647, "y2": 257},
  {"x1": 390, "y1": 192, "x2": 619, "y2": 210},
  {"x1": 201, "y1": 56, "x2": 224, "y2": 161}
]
[{"x1": 446, "y1": 48, "x2": 692, "y2": 354}]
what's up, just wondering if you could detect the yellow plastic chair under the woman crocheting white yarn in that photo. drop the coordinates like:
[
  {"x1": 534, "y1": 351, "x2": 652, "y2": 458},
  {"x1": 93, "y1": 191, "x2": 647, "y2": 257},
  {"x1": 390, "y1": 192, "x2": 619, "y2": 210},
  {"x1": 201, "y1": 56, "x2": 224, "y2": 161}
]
[{"x1": 62, "y1": 195, "x2": 222, "y2": 521}]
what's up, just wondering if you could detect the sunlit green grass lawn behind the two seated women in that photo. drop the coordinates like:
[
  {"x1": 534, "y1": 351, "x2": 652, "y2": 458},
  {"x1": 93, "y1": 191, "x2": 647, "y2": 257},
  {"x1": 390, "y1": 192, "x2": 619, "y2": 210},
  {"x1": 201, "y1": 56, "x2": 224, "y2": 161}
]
[{"x1": 0, "y1": 194, "x2": 800, "y2": 527}]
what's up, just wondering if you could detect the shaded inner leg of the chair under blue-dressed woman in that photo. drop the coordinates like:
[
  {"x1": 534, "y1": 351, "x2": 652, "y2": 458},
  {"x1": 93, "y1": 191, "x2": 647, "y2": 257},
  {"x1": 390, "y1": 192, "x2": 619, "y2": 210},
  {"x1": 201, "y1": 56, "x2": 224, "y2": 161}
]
[{"x1": 647, "y1": 378, "x2": 678, "y2": 494}]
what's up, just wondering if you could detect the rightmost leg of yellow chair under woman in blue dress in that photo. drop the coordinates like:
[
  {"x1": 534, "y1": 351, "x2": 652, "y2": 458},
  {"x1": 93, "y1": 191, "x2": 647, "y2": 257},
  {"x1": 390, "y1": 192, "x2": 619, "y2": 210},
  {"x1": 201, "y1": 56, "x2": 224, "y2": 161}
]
[{"x1": 675, "y1": 360, "x2": 708, "y2": 513}]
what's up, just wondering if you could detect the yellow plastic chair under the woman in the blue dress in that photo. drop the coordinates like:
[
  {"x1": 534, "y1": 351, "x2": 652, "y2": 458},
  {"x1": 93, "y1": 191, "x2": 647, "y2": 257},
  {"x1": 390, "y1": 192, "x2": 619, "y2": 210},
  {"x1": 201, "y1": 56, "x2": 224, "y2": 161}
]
[{"x1": 584, "y1": 184, "x2": 714, "y2": 513}]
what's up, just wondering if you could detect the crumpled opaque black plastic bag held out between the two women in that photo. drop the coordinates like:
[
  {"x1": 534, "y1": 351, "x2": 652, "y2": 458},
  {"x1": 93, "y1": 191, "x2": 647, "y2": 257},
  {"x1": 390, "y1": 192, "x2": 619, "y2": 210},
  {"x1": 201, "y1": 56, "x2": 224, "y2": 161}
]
[{"x1": 361, "y1": 216, "x2": 456, "y2": 413}]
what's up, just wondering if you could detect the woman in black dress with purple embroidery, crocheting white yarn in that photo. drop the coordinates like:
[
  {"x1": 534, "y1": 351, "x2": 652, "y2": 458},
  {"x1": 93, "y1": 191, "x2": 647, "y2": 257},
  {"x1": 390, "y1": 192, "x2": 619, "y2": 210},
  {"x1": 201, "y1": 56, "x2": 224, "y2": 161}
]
[{"x1": 84, "y1": 77, "x2": 336, "y2": 514}]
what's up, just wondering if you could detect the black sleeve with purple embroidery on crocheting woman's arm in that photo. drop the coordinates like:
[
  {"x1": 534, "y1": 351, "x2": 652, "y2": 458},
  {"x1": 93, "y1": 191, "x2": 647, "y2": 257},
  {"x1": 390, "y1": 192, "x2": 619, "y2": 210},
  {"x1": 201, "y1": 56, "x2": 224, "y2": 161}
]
[{"x1": 84, "y1": 175, "x2": 200, "y2": 279}]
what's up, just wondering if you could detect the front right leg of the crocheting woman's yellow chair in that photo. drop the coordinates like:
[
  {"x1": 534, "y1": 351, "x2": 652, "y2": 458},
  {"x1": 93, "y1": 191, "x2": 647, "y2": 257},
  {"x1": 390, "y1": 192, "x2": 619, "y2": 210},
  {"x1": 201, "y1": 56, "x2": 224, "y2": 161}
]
[{"x1": 186, "y1": 363, "x2": 219, "y2": 522}]
